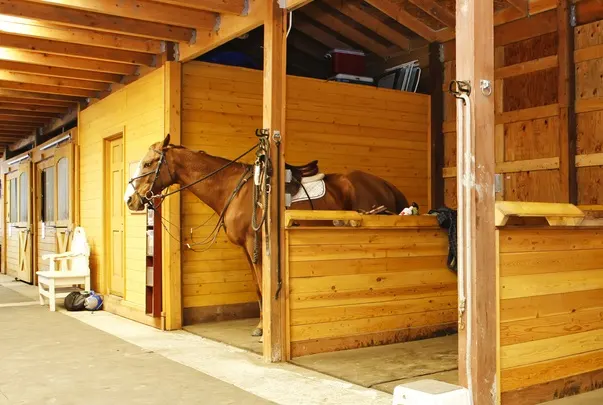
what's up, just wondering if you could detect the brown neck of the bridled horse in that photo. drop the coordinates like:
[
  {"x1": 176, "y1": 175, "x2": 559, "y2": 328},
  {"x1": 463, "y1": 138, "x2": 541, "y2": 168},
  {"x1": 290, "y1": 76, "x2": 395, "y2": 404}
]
[{"x1": 173, "y1": 149, "x2": 244, "y2": 214}]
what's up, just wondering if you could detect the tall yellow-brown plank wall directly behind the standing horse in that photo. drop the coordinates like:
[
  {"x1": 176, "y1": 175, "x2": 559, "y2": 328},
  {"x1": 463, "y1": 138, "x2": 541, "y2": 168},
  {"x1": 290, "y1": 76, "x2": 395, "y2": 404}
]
[{"x1": 182, "y1": 62, "x2": 429, "y2": 323}]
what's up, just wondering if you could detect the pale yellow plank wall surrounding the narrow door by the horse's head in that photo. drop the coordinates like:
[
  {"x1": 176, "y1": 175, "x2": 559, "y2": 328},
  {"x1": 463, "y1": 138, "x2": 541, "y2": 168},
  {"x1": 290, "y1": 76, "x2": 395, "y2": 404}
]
[{"x1": 78, "y1": 68, "x2": 164, "y2": 314}]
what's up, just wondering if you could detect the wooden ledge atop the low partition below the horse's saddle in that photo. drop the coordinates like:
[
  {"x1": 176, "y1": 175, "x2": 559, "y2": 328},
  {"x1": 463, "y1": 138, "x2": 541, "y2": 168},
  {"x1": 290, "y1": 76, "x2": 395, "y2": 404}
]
[{"x1": 285, "y1": 210, "x2": 439, "y2": 229}]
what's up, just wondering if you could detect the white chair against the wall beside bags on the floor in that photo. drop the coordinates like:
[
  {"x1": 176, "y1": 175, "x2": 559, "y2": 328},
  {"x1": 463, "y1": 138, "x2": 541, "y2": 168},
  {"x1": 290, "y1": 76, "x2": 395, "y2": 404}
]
[{"x1": 36, "y1": 227, "x2": 90, "y2": 311}]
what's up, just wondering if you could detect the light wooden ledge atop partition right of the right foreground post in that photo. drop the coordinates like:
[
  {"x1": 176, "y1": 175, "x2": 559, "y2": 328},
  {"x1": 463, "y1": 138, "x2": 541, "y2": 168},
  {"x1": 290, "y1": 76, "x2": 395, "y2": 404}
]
[{"x1": 494, "y1": 201, "x2": 585, "y2": 226}]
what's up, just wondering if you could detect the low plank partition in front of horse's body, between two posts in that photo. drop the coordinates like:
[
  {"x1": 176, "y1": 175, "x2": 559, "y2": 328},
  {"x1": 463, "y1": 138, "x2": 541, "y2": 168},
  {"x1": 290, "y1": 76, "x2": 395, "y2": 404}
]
[{"x1": 286, "y1": 217, "x2": 458, "y2": 357}]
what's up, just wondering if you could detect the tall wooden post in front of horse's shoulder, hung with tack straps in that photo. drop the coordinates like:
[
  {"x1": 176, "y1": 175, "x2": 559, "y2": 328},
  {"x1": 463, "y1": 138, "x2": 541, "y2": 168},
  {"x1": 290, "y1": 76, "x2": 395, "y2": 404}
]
[{"x1": 262, "y1": 0, "x2": 287, "y2": 362}]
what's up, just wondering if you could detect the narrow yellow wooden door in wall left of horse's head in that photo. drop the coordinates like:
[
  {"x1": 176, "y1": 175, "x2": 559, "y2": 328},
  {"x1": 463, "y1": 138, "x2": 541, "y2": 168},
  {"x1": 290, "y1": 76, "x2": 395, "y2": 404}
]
[{"x1": 107, "y1": 138, "x2": 125, "y2": 297}]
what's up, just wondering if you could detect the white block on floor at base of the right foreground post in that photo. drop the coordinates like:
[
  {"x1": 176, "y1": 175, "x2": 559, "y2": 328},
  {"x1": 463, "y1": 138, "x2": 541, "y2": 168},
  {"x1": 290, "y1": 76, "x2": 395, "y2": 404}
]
[{"x1": 392, "y1": 380, "x2": 470, "y2": 405}]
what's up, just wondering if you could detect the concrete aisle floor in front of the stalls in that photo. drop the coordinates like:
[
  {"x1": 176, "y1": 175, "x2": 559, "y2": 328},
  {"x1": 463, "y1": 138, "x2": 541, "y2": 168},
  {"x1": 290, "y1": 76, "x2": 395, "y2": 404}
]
[{"x1": 0, "y1": 274, "x2": 392, "y2": 405}]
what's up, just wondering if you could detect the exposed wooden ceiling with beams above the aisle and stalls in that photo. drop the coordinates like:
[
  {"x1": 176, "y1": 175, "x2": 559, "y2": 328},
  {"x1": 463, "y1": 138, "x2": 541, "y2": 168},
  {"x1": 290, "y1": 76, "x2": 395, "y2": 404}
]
[{"x1": 0, "y1": 0, "x2": 556, "y2": 145}]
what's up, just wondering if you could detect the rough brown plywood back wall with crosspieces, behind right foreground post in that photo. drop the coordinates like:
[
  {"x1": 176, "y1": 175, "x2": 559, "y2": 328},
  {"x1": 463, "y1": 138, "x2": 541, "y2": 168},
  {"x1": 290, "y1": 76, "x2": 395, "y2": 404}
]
[{"x1": 443, "y1": 10, "x2": 569, "y2": 207}]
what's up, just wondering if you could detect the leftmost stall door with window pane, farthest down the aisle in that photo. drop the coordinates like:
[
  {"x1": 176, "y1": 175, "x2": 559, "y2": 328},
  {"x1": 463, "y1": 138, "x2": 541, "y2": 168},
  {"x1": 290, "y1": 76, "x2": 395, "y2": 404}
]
[{"x1": 5, "y1": 161, "x2": 33, "y2": 283}]
